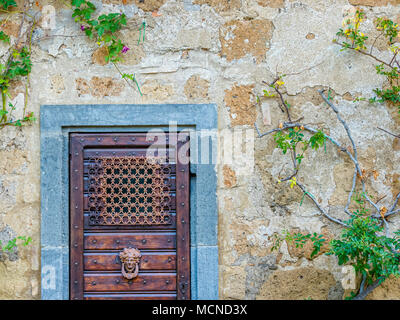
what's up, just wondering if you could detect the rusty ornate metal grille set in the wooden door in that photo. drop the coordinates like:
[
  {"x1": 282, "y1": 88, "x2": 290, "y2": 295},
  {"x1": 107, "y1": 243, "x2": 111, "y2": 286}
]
[{"x1": 88, "y1": 156, "x2": 171, "y2": 225}]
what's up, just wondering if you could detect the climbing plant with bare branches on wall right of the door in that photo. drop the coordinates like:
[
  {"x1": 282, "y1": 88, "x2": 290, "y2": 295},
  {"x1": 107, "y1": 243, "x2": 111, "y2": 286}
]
[{"x1": 255, "y1": 10, "x2": 400, "y2": 300}]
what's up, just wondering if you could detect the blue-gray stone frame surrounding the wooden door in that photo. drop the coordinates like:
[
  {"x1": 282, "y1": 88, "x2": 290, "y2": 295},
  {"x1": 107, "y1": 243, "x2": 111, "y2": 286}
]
[{"x1": 40, "y1": 104, "x2": 218, "y2": 300}]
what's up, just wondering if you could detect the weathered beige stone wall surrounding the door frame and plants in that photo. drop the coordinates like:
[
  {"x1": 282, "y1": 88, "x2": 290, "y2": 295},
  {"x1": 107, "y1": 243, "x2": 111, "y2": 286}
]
[{"x1": 0, "y1": 0, "x2": 400, "y2": 299}]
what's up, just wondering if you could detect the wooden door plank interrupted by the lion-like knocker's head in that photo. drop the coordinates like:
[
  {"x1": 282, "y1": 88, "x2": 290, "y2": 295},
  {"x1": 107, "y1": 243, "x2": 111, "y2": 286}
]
[{"x1": 84, "y1": 251, "x2": 176, "y2": 271}]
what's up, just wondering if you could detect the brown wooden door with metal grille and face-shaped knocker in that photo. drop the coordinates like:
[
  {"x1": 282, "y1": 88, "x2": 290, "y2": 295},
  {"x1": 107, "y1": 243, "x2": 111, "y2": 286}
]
[{"x1": 70, "y1": 133, "x2": 190, "y2": 299}]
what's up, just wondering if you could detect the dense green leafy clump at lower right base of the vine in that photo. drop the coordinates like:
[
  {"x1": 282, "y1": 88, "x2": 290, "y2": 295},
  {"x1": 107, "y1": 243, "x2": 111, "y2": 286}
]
[{"x1": 271, "y1": 196, "x2": 400, "y2": 300}]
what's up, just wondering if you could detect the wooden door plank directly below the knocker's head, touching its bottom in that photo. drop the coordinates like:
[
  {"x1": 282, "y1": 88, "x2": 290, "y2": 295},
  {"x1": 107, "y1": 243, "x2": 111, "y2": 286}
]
[{"x1": 84, "y1": 272, "x2": 176, "y2": 291}]
